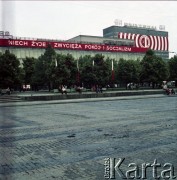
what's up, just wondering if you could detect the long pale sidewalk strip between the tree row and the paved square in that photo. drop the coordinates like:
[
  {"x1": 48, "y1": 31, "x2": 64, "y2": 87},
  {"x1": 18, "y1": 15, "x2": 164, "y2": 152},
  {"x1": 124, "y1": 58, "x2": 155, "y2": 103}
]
[{"x1": 0, "y1": 89, "x2": 176, "y2": 107}]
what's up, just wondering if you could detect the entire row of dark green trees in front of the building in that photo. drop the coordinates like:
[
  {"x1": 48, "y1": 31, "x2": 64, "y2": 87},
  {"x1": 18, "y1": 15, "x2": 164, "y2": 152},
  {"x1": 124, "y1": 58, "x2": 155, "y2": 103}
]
[{"x1": 0, "y1": 45, "x2": 174, "y2": 90}]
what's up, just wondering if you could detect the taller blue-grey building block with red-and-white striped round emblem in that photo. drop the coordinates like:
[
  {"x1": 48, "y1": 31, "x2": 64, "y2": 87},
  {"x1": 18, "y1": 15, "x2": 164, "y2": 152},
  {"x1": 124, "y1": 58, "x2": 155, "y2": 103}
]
[{"x1": 103, "y1": 24, "x2": 169, "y2": 59}]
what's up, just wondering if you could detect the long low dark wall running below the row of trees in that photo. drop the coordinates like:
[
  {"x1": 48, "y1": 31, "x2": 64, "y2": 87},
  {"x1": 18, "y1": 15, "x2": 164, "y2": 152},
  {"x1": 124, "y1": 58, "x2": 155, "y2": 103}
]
[{"x1": 21, "y1": 89, "x2": 164, "y2": 101}]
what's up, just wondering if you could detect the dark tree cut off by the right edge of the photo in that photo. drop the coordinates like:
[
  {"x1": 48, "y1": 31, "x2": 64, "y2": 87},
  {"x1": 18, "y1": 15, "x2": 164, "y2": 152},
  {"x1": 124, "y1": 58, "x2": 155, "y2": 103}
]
[{"x1": 168, "y1": 56, "x2": 177, "y2": 86}]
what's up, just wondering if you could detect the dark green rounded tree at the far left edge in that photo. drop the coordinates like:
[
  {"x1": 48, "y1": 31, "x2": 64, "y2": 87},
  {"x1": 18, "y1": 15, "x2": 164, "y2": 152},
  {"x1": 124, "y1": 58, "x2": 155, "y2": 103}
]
[{"x1": 0, "y1": 50, "x2": 22, "y2": 88}]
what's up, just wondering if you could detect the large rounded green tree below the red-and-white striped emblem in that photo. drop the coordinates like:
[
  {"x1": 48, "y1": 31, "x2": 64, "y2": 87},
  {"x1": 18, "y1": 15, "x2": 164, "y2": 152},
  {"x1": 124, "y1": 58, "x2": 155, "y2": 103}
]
[{"x1": 140, "y1": 50, "x2": 169, "y2": 87}]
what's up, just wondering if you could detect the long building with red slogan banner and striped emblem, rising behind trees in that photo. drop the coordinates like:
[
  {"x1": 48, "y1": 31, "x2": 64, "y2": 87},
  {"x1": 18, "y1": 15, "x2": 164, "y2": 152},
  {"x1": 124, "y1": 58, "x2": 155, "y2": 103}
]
[{"x1": 0, "y1": 26, "x2": 169, "y2": 61}]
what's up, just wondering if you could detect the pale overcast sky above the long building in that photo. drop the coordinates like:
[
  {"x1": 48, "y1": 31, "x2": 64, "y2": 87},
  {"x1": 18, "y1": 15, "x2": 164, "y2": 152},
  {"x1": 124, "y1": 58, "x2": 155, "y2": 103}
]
[{"x1": 0, "y1": 0, "x2": 177, "y2": 55}]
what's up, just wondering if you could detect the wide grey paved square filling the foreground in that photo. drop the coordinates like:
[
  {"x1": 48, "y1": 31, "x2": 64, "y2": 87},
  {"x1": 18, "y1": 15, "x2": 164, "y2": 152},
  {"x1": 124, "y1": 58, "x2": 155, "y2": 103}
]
[{"x1": 0, "y1": 96, "x2": 177, "y2": 180}]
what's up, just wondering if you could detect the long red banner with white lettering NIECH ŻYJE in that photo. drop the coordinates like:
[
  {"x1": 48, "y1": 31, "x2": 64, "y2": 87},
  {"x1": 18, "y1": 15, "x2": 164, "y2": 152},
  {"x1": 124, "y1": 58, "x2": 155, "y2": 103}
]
[{"x1": 0, "y1": 39, "x2": 147, "y2": 53}]
